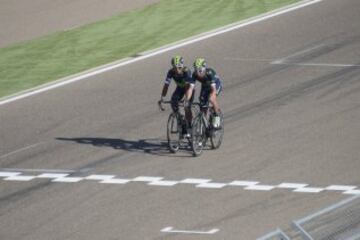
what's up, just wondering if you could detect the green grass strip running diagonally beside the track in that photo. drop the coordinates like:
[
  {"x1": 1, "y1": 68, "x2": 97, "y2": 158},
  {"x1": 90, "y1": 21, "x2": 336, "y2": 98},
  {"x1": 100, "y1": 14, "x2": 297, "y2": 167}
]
[{"x1": 0, "y1": 0, "x2": 299, "y2": 97}]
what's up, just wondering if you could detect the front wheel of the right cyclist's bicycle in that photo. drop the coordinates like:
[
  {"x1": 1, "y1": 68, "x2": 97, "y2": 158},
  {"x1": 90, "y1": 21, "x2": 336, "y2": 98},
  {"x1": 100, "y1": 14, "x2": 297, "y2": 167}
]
[{"x1": 191, "y1": 114, "x2": 206, "y2": 157}]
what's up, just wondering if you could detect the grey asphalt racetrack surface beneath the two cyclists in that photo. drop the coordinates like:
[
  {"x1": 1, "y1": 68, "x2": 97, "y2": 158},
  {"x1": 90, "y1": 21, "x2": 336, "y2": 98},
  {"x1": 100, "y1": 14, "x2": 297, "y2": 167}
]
[{"x1": 0, "y1": 0, "x2": 360, "y2": 240}]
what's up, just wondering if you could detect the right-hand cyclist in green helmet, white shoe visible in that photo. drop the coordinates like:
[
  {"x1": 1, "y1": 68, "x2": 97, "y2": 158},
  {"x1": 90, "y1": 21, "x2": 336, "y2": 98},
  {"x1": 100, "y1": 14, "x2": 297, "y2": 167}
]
[{"x1": 192, "y1": 58, "x2": 222, "y2": 128}]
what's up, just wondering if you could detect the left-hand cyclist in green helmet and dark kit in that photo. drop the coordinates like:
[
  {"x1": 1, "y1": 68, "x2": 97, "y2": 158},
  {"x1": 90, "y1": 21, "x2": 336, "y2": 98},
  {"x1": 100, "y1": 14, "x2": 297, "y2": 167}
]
[{"x1": 159, "y1": 55, "x2": 195, "y2": 135}]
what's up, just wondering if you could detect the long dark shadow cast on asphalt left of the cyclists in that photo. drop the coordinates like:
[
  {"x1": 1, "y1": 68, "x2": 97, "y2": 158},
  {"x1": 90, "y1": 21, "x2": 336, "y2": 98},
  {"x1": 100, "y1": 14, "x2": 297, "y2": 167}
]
[{"x1": 56, "y1": 137, "x2": 190, "y2": 157}]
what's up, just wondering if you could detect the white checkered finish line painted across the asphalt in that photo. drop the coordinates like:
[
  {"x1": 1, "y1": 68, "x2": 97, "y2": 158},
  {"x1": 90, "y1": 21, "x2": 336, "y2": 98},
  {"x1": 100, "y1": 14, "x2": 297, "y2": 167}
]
[{"x1": 0, "y1": 171, "x2": 360, "y2": 195}]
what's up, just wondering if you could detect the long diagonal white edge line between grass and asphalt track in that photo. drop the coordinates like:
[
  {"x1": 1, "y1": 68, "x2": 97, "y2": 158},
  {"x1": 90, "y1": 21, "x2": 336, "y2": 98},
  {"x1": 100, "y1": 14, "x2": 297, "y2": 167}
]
[{"x1": 0, "y1": 0, "x2": 322, "y2": 105}]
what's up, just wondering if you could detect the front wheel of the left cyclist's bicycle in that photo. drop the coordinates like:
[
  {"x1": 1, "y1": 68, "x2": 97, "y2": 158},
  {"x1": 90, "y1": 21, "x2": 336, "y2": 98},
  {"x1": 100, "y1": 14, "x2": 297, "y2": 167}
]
[{"x1": 167, "y1": 113, "x2": 182, "y2": 153}]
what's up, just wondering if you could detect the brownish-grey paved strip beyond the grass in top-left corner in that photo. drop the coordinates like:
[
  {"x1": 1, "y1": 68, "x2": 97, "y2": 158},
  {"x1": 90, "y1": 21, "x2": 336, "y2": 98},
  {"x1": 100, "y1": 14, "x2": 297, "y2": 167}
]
[{"x1": 0, "y1": 0, "x2": 158, "y2": 47}]
